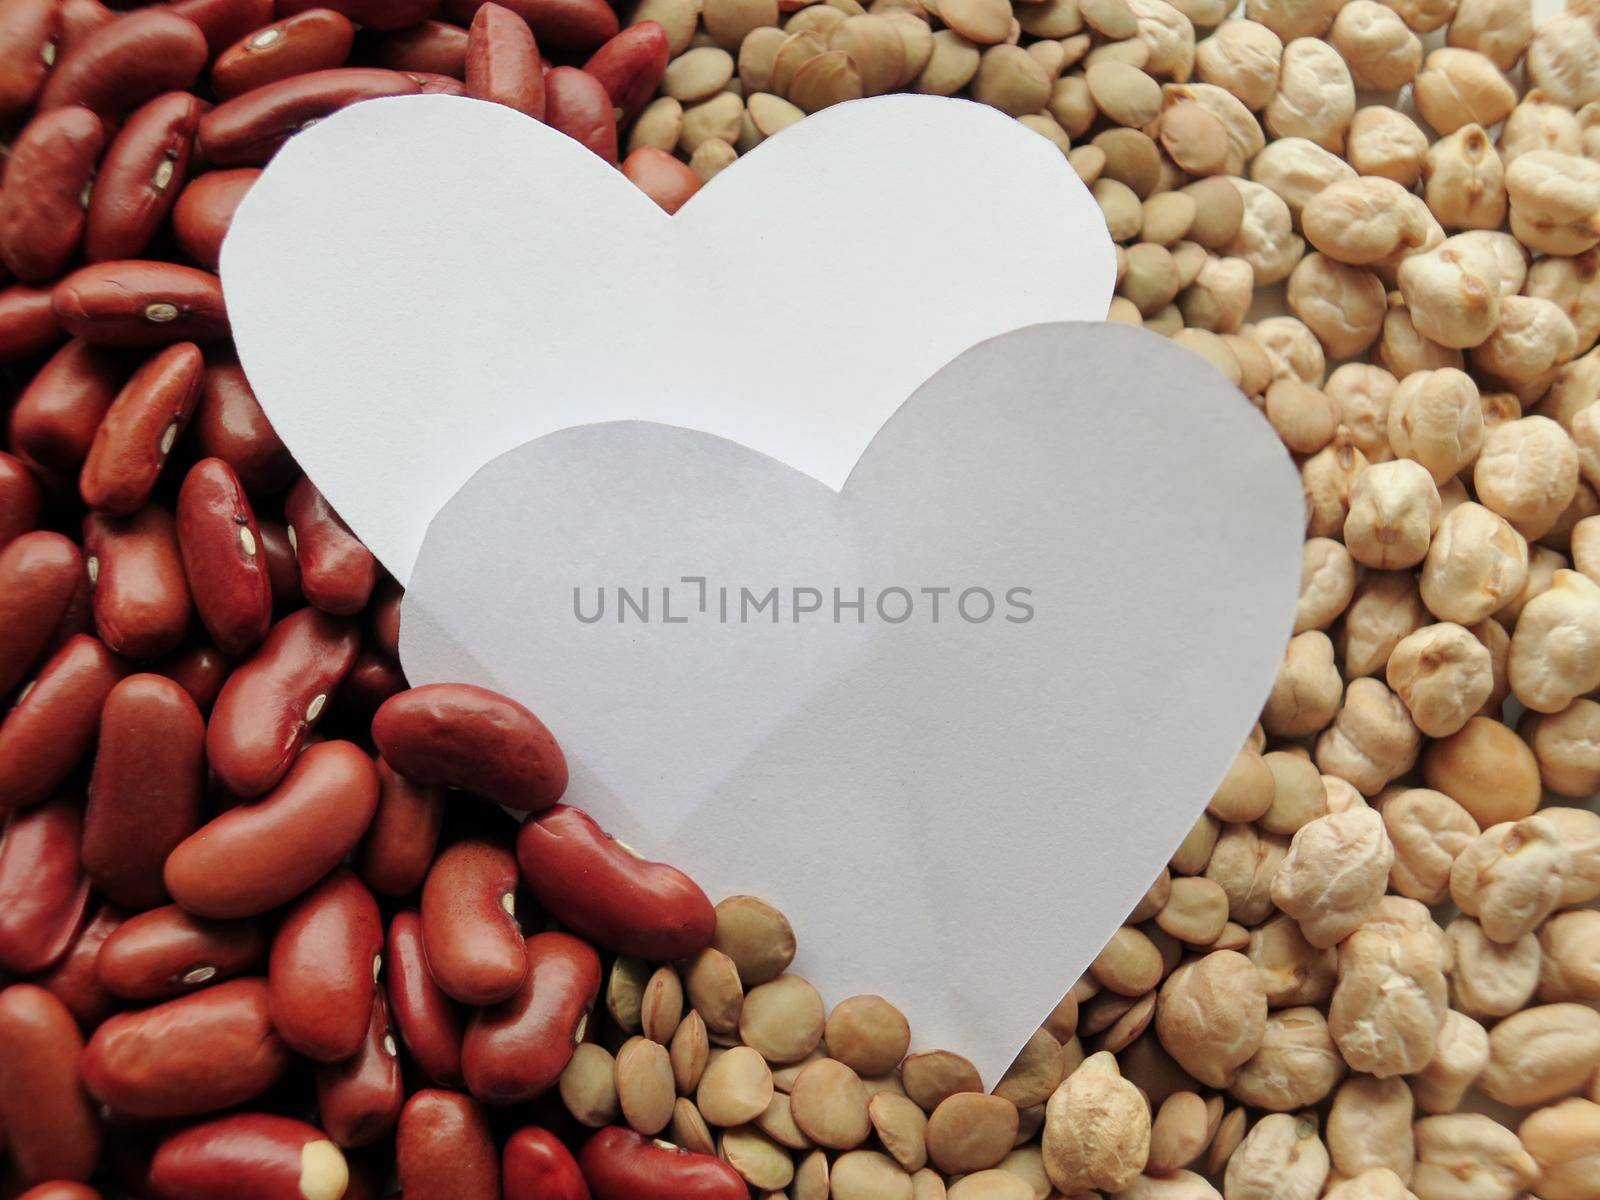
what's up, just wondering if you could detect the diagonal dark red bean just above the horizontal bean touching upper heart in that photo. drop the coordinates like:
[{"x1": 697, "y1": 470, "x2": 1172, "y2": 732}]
[{"x1": 83, "y1": 91, "x2": 202, "y2": 262}]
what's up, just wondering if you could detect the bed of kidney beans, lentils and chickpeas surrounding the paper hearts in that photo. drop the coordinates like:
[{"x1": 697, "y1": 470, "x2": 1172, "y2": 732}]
[{"x1": 0, "y1": 0, "x2": 1600, "y2": 1200}]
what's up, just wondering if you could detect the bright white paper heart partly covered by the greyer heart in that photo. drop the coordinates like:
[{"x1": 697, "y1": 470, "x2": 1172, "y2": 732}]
[{"x1": 221, "y1": 96, "x2": 1115, "y2": 582}]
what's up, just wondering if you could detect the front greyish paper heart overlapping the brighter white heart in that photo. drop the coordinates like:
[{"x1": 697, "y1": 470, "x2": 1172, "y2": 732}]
[{"x1": 400, "y1": 325, "x2": 1304, "y2": 1085}]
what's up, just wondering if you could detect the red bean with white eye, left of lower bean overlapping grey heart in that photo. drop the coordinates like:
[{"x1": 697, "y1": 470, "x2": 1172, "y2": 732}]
[{"x1": 422, "y1": 840, "x2": 528, "y2": 1005}]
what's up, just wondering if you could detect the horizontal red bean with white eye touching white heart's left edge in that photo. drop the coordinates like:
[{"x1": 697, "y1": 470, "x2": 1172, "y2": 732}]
[{"x1": 51, "y1": 259, "x2": 227, "y2": 347}]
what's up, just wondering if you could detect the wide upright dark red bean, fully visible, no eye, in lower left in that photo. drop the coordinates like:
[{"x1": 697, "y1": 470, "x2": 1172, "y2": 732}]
[{"x1": 83, "y1": 675, "x2": 205, "y2": 909}]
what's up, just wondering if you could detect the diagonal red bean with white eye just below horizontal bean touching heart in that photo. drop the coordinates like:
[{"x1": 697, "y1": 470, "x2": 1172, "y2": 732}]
[{"x1": 78, "y1": 342, "x2": 205, "y2": 517}]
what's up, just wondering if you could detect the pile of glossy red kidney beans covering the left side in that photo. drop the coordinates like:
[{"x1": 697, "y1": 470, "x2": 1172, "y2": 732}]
[{"x1": 0, "y1": 0, "x2": 747, "y2": 1200}]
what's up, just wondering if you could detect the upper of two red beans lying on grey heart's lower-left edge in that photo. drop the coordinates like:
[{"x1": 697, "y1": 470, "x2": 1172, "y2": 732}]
[{"x1": 373, "y1": 683, "x2": 566, "y2": 813}]
